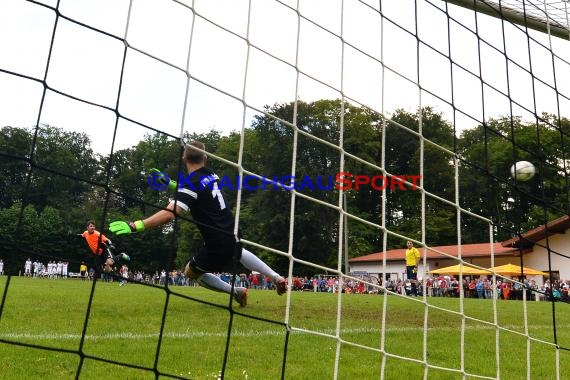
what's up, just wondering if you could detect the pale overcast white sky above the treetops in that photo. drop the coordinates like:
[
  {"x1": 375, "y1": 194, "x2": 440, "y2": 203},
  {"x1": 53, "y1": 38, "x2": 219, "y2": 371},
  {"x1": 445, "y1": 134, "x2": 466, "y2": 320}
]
[{"x1": 0, "y1": 0, "x2": 570, "y2": 154}]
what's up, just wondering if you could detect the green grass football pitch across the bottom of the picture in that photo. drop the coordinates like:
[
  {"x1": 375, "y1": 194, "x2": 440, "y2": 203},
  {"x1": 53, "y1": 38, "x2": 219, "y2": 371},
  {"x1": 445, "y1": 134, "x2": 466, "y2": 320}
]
[{"x1": 0, "y1": 277, "x2": 570, "y2": 380}]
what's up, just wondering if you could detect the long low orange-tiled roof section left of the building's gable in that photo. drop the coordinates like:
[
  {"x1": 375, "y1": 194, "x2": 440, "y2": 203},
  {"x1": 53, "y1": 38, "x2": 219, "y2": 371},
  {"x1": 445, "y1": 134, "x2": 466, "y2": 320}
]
[{"x1": 348, "y1": 243, "x2": 519, "y2": 263}]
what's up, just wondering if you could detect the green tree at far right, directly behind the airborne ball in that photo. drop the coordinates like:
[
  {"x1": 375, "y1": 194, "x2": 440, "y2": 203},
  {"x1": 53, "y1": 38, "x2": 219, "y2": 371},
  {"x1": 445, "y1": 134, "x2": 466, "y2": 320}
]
[{"x1": 458, "y1": 115, "x2": 569, "y2": 241}]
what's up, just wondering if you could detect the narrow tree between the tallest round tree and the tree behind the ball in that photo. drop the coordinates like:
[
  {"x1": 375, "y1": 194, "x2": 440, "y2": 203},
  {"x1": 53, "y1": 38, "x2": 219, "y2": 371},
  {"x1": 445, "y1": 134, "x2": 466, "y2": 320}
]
[{"x1": 385, "y1": 107, "x2": 456, "y2": 247}]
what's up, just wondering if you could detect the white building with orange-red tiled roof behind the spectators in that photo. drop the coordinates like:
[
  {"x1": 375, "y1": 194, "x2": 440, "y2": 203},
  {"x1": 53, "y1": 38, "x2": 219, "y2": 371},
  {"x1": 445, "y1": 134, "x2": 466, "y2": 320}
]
[{"x1": 349, "y1": 215, "x2": 570, "y2": 283}]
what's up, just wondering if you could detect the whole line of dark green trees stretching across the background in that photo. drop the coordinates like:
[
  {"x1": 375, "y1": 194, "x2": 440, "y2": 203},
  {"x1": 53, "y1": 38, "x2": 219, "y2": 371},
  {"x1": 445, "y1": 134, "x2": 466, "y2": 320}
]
[{"x1": 0, "y1": 100, "x2": 570, "y2": 274}]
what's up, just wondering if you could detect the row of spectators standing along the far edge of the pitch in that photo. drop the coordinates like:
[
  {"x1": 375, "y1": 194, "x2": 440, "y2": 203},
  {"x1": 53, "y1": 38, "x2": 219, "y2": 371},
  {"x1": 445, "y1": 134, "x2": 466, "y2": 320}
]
[{"x1": 6, "y1": 258, "x2": 570, "y2": 302}]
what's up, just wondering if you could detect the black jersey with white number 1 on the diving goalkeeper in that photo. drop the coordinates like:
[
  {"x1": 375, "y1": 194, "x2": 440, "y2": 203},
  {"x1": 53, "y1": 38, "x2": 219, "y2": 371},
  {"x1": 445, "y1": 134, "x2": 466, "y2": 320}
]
[{"x1": 176, "y1": 167, "x2": 235, "y2": 247}]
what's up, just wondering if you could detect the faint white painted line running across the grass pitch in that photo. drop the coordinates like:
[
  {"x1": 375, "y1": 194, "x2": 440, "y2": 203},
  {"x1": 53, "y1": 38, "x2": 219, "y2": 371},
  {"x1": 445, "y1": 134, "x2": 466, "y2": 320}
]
[{"x1": 0, "y1": 325, "x2": 552, "y2": 340}]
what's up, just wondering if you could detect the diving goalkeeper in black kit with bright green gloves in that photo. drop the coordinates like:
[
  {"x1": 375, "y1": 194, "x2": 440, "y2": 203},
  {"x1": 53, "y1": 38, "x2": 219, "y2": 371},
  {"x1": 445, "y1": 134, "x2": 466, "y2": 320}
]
[{"x1": 109, "y1": 141, "x2": 287, "y2": 307}]
